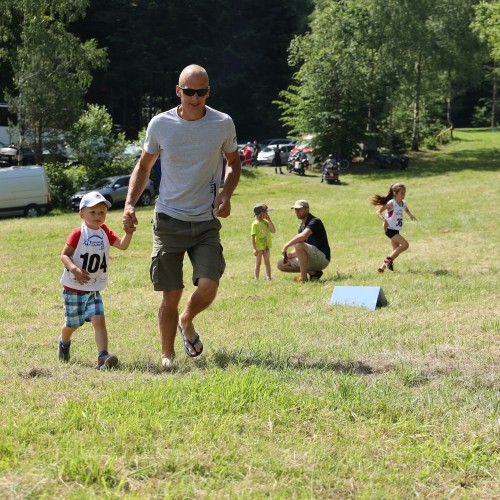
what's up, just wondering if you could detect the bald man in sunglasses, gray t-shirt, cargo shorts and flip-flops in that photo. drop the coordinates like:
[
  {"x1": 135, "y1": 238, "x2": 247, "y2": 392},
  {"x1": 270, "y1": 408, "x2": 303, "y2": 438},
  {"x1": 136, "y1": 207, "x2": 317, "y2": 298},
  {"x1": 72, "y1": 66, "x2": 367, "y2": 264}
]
[{"x1": 123, "y1": 65, "x2": 241, "y2": 369}]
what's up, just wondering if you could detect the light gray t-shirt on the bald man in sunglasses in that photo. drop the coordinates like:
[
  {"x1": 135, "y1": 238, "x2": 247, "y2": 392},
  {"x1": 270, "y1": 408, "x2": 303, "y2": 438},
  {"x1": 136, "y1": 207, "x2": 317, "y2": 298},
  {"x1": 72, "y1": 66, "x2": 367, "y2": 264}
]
[{"x1": 144, "y1": 106, "x2": 238, "y2": 222}]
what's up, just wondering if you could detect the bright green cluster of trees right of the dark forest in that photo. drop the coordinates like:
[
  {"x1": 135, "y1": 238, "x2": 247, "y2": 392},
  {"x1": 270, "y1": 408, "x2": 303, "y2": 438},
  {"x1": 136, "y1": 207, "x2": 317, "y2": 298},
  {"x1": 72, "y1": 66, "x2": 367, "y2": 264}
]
[{"x1": 280, "y1": 0, "x2": 482, "y2": 155}]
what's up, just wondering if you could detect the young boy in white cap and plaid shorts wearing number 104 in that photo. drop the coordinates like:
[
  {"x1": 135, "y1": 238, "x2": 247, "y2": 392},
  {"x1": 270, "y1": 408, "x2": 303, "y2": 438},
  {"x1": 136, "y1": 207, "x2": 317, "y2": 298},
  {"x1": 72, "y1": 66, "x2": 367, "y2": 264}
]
[{"x1": 57, "y1": 191, "x2": 134, "y2": 369}]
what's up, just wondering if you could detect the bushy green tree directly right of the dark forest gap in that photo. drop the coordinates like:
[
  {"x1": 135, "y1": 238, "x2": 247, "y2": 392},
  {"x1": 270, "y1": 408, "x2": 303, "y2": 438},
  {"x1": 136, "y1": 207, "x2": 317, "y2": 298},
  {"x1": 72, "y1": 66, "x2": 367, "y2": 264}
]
[{"x1": 279, "y1": 0, "x2": 376, "y2": 157}]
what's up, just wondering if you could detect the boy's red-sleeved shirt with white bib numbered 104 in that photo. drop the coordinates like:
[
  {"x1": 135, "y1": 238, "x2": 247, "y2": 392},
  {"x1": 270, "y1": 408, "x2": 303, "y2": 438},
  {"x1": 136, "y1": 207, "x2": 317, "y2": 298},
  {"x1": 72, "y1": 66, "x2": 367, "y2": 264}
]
[{"x1": 60, "y1": 223, "x2": 118, "y2": 292}]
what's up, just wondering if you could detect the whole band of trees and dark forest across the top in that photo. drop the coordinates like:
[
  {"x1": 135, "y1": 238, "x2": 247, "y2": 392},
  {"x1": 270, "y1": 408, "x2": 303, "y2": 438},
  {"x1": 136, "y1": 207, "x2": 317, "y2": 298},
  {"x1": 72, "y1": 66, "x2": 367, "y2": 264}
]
[{"x1": 0, "y1": 0, "x2": 500, "y2": 158}]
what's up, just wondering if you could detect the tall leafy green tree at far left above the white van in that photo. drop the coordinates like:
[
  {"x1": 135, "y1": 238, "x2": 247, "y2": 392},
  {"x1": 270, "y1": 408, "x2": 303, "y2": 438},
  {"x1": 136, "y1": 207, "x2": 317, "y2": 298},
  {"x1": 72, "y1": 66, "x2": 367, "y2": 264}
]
[{"x1": 0, "y1": 0, "x2": 105, "y2": 159}]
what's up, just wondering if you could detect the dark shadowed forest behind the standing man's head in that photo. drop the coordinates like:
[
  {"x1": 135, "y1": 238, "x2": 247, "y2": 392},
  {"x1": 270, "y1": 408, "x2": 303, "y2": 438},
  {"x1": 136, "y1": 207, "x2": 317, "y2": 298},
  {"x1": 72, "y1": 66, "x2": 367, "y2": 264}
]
[{"x1": 72, "y1": 0, "x2": 312, "y2": 139}]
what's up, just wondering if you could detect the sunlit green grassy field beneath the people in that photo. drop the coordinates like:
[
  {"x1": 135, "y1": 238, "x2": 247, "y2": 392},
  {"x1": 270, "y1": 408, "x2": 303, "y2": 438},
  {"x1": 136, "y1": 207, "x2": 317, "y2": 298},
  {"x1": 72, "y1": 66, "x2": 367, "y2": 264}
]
[{"x1": 0, "y1": 129, "x2": 500, "y2": 499}]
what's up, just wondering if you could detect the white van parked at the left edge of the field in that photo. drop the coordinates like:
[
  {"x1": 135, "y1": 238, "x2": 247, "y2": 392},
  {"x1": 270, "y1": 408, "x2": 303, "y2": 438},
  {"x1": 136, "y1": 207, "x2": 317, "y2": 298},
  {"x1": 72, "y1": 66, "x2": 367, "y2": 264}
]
[{"x1": 0, "y1": 165, "x2": 52, "y2": 217}]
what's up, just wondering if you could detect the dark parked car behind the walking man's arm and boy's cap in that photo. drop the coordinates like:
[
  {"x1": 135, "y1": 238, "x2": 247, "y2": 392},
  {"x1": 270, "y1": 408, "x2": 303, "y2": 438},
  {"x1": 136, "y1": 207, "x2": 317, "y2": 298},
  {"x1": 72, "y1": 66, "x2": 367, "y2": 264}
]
[{"x1": 71, "y1": 175, "x2": 155, "y2": 212}]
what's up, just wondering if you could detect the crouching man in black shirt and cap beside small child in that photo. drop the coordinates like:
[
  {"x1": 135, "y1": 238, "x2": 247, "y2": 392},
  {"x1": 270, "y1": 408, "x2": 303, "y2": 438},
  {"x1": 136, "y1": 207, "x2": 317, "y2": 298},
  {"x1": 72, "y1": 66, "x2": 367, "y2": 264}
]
[{"x1": 278, "y1": 200, "x2": 330, "y2": 283}]
